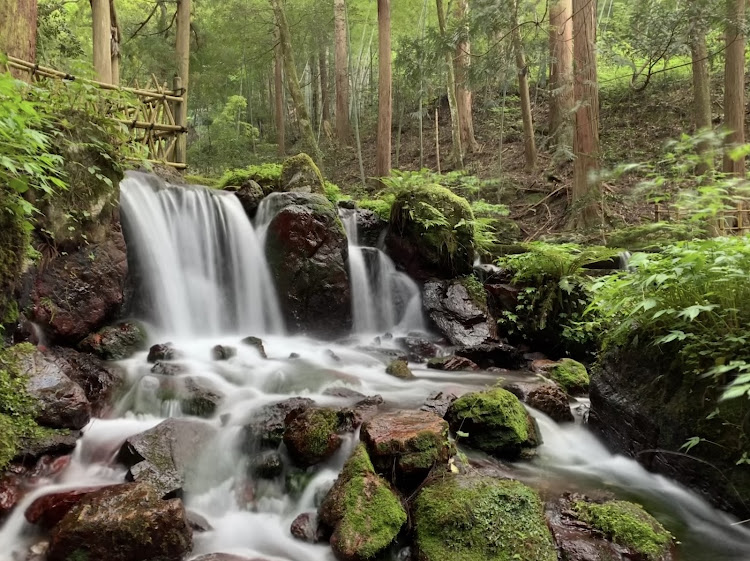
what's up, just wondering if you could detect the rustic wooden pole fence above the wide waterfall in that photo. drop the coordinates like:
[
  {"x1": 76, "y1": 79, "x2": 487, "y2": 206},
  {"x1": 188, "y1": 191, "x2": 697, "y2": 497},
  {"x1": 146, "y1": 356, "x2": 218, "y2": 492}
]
[{"x1": 7, "y1": 57, "x2": 187, "y2": 169}]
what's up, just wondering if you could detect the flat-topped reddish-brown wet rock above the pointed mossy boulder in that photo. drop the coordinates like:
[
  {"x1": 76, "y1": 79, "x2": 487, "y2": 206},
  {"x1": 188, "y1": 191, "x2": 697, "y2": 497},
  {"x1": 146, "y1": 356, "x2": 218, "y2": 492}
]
[{"x1": 360, "y1": 411, "x2": 454, "y2": 488}]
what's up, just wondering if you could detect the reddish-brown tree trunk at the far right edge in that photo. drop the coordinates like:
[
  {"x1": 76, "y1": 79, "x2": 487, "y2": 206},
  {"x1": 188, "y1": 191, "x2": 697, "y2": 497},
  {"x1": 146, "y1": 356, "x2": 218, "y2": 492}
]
[{"x1": 724, "y1": 0, "x2": 745, "y2": 177}]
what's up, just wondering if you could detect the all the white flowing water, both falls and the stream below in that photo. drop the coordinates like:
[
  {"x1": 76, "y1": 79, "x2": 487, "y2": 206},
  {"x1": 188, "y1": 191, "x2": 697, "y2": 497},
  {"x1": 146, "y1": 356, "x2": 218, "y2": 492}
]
[{"x1": 0, "y1": 173, "x2": 750, "y2": 561}]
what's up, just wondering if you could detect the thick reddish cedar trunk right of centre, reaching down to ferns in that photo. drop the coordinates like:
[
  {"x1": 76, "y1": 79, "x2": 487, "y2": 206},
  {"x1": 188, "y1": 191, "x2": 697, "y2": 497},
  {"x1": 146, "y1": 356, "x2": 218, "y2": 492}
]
[{"x1": 572, "y1": 0, "x2": 599, "y2": 227}]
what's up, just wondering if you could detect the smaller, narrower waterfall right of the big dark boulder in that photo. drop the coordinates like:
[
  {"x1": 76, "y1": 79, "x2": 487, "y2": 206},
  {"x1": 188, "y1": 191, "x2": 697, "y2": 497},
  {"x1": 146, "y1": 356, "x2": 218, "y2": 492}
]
[{"x1": 339, "y1": 208, "x2": 425, "y2": 333}]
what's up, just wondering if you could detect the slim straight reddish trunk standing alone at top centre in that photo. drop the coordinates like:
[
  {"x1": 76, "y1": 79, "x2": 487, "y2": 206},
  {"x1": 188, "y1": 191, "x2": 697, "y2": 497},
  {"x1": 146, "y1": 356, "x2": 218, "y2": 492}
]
[{"x1": 375, "y1": 0, "x2": 393, "y2": 177}]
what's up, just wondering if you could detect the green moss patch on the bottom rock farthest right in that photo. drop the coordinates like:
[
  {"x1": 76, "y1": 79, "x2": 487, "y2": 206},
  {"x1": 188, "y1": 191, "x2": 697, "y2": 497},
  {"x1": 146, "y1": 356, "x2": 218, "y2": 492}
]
[{"x1": 573, "y1": 501, "x2": 672, "y2": 561}]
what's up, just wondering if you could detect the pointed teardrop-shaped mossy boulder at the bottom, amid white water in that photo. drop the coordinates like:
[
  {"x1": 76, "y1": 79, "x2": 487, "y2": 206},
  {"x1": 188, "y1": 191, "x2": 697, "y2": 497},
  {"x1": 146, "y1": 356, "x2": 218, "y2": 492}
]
[{"x1": 318, "y1": 444, "x2": 406, "y2": 561}]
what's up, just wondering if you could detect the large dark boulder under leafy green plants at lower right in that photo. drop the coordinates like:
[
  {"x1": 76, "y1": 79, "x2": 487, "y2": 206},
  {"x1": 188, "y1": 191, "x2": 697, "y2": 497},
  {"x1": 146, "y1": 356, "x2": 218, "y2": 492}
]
[{"x1": 589, "y1": 347, "x2": 750, "y2": 520}]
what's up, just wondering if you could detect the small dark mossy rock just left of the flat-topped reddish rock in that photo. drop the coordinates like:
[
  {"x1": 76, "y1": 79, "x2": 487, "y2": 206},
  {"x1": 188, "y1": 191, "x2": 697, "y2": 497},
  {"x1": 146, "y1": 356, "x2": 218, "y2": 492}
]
[{"x1": 284, "y1": 408, "x2": 341, "y2": 467}]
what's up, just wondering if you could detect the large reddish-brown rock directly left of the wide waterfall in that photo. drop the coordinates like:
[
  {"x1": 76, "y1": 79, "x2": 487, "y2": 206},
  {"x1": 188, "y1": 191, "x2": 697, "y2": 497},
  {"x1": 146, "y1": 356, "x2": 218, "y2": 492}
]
[{"x1": 29, "y1": 233, "x2": 128, "y2": 345}]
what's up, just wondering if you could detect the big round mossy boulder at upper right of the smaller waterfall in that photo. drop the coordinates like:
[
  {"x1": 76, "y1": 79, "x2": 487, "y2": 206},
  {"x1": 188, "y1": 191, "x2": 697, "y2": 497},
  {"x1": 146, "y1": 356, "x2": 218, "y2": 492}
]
[{"x1": 386, "y1": 185, "x2": 474, "y2": 280}]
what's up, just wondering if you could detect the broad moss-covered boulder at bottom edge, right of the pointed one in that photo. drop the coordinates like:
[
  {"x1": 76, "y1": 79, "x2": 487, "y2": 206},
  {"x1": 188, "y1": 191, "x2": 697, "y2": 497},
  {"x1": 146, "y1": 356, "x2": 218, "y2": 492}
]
[{"x1": 414, "y1": 475, "x2": 557, "y2": 561}]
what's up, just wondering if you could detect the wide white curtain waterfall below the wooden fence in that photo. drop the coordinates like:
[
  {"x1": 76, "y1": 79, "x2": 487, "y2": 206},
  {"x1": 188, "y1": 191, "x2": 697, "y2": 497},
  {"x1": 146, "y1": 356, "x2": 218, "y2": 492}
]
[{"x1": 121, "y1": 172, "x2": 283, "y2": 335}]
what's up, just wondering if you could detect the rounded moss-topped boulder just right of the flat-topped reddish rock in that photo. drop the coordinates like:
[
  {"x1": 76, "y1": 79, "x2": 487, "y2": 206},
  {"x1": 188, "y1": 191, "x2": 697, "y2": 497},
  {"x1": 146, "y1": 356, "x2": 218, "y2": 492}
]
[{"x1": 446, "y1": 388, "x2": 538, "y2": 459}]
